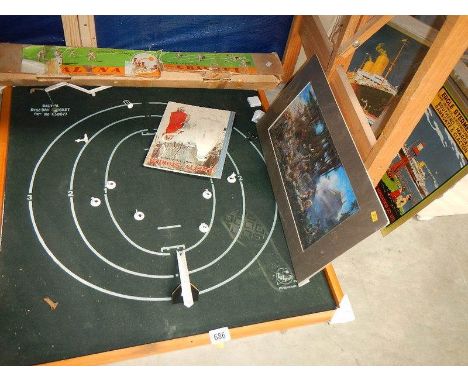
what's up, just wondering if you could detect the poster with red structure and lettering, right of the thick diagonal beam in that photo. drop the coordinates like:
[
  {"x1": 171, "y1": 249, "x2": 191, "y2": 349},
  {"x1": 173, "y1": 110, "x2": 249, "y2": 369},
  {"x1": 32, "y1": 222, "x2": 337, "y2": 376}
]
[{"x1": 376, "y1": 79, "x2": 468, "y2": 233}]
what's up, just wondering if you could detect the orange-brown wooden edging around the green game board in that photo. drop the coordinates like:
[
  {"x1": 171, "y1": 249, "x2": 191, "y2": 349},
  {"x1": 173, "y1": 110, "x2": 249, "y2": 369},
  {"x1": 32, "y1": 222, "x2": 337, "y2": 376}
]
[{"x1": 0, "y1": 87, "x2": 344, "y2": 366}]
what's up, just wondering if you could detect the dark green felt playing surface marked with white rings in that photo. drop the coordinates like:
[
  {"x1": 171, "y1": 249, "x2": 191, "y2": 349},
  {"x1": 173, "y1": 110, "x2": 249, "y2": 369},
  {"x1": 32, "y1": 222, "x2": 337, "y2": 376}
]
[{"x1": 0, "y1": 88, "x2": 335, "y2": 364}]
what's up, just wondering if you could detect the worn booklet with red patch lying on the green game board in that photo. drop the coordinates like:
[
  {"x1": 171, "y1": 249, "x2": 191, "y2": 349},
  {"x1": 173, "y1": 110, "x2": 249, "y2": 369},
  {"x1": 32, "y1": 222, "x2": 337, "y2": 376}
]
[{"x1": 144, "y1": 102, "x2": 235, "y2": 178}]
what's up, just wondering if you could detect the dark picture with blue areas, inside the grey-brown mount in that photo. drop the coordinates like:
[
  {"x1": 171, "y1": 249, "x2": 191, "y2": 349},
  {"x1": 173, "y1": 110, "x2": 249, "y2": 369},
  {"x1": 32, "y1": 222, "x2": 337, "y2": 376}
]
[{"x1": 269, "y1": 83, "x2": 359, "y2": 249}]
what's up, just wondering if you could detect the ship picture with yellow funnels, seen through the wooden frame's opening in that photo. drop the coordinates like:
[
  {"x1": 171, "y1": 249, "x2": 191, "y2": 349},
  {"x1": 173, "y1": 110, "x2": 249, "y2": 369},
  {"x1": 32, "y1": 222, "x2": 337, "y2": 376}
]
[{"x1": 347, "y1": 25, "x2": 427, "y2": 132}]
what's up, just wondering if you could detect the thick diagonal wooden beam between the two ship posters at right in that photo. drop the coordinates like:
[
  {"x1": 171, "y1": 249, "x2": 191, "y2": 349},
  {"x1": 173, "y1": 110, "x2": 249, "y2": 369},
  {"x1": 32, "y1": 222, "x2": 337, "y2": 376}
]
[{"x1": 365, "y1": 16, "x2": 468, "y2": 185}]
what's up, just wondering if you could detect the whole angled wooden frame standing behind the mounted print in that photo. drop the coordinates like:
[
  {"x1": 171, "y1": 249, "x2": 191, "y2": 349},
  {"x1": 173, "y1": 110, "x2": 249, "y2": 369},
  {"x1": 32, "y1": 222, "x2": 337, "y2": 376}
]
[{"x1": 283, "y1": 16, "x2": 468, "y2": 185}]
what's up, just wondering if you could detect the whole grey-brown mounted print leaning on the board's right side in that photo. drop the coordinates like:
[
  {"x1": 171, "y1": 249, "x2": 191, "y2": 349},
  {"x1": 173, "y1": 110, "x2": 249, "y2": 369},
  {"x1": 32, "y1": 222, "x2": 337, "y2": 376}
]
[{"x1": 257, "y1": 56, "x2": 388, "y2": 285}]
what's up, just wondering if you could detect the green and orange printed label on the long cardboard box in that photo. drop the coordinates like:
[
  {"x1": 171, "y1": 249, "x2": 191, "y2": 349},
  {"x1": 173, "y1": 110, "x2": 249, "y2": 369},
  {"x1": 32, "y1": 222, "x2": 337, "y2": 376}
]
[{"x1": 22, "y1": 45, "x2": 256, "y2": 78}]
